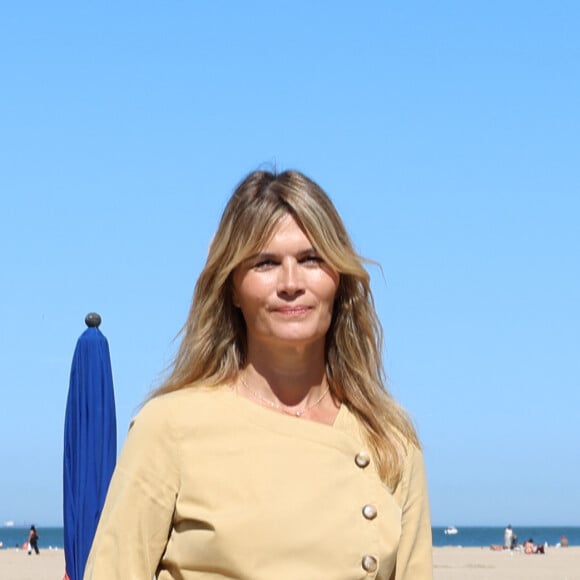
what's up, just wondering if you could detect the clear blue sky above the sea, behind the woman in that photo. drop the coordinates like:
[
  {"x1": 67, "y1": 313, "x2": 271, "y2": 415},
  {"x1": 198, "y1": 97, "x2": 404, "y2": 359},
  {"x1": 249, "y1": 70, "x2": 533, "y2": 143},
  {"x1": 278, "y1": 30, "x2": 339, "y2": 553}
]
[{"x1": 0, "y1": 0, "x2": 580, "y2": 525}]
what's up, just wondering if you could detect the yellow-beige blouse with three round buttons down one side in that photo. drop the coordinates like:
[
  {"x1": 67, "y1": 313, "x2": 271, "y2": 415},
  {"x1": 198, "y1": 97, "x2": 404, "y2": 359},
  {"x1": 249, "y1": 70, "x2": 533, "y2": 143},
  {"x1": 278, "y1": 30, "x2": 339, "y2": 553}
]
[{"x1": 84, "y1": 387, "x2": 432, "y2": 580}]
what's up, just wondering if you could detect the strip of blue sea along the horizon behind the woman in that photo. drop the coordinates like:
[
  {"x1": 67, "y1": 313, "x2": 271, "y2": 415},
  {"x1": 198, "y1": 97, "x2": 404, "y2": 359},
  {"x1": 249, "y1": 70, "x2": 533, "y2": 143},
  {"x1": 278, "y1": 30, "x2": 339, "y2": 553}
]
[{"x1": 0, "y1": 526, "x2": 580, "y2": 550}]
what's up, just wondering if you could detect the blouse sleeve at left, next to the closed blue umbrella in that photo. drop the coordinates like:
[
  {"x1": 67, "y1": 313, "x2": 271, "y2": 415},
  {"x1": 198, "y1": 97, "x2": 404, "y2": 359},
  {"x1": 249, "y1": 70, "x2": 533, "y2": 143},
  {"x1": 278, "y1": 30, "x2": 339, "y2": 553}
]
[{"x1": 84, "y1": 399, "x2": 179, "y2": 580}]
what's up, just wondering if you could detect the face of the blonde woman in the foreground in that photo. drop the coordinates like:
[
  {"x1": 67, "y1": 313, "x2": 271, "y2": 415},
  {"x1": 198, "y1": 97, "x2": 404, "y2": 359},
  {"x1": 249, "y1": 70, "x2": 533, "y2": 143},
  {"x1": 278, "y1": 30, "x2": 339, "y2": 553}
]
[{"x1": 233, "y1": 215, "x2": 339, "y2": 348}]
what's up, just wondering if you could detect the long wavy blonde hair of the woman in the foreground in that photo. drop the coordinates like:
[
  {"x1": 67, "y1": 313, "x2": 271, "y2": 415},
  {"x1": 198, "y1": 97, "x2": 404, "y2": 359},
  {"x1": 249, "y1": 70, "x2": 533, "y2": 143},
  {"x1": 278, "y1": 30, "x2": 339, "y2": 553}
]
[{"x1": 152, "y1": 171, "x2": 419, "y2": 489}]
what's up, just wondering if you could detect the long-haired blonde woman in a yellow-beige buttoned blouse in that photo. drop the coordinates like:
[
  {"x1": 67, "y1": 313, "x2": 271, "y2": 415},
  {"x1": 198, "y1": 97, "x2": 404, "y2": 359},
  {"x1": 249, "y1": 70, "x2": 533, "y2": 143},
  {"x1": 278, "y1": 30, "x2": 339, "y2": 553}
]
[{"x1": 85, "y1": 171, "x2": 432, "y2": 580}]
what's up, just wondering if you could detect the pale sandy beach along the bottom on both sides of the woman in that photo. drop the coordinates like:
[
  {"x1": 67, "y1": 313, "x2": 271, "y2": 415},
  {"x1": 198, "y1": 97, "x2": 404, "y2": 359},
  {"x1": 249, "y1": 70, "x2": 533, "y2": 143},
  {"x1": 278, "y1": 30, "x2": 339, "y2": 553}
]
[{"x1": 0, "y1": 547, "x2": 580, "y2": 580}]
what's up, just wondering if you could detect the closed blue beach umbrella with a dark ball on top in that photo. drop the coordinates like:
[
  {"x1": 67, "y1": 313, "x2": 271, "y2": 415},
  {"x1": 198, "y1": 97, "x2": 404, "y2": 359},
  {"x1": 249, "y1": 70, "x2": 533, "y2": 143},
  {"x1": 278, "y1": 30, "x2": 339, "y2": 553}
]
[{"x1": 63, "y1": 313, "x2": 117, "y2": 580}]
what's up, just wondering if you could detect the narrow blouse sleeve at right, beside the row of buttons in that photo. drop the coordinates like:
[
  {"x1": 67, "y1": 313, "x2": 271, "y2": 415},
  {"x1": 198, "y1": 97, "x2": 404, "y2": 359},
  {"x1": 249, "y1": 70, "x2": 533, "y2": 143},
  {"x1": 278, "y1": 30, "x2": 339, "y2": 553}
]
[{"x1": 392, "y1": 446, "x2": 433, "y2": 580}]
